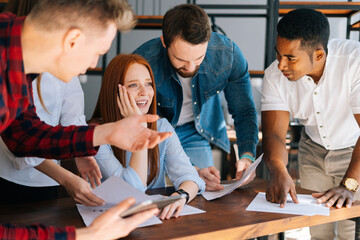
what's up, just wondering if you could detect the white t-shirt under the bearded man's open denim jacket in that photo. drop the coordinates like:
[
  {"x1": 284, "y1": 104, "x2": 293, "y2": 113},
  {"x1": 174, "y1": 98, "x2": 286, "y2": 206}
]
[{"x1": 177, "y1": 74, "x2": 194, "y2": 126}]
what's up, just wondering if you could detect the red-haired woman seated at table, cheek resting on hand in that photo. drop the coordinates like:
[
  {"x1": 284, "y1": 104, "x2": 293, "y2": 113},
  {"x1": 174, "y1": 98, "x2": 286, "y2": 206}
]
[{"x1": 92, "y1": 54, "x2": 205, "y2": 219}]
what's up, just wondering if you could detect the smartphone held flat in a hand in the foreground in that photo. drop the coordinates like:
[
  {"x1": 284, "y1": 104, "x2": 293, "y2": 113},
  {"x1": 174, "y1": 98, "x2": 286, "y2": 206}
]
[{"x1": 120, "y1": 194, "x2": 186, "y2": 218}]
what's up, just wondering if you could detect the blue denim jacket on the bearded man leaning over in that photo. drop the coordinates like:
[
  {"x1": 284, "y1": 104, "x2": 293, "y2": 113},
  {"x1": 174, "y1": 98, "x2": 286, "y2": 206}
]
[{"x1": 134, "y1": 33, "x2": 258, "y2": 156}]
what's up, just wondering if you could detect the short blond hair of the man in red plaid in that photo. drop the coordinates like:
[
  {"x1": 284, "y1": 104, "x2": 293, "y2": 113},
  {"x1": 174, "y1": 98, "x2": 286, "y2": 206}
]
[{"x1": 28, "y1": 0, "x2": 136, "y2": 32}]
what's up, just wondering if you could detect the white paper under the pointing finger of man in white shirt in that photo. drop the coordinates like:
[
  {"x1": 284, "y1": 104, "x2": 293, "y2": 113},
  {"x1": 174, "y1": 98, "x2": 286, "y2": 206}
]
[{"x1": 246, "y1": 192, "x2": 330, "y2": 216}]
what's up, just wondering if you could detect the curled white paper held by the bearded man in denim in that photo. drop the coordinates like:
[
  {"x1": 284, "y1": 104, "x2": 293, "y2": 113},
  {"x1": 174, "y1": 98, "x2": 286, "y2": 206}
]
[{"x1": 202, "y1": 154, "x2": 263, "y2": 201}]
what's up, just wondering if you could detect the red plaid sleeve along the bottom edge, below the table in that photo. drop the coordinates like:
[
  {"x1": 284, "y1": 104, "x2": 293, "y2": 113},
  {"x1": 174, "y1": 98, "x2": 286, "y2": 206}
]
[{"x1": 0, "y1": 224, "x2": 75, "y2": 240}]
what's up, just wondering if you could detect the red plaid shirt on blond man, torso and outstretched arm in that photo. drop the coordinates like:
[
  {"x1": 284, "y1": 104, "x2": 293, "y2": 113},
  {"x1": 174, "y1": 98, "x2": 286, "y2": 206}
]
[{"x1": 0, "y1": 13, "x2": 97, "y2": 159}]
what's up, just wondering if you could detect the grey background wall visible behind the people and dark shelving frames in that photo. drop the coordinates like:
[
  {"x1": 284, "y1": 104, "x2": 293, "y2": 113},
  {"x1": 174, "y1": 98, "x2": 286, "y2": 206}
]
[{"x1": 82, "y1": 0, "x2": 360, "y2": 119}]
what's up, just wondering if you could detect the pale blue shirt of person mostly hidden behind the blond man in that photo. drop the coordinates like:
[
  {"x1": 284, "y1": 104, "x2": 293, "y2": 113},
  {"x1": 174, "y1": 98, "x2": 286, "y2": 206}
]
[{"x1": 0, "y1": 73, "x2": 86, "y2": 187}]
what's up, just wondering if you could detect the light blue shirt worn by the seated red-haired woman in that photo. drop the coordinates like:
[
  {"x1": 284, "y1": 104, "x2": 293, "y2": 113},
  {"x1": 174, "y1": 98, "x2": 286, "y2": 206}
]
[{"x1": 95, "y1": 118, "x2": 205, "y2": 193}]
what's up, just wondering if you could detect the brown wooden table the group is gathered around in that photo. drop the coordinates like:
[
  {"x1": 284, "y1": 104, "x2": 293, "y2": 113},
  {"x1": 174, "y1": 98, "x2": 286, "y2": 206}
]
[{"x1": 0, "y1": 179, "x2": 360, "y2": 240}]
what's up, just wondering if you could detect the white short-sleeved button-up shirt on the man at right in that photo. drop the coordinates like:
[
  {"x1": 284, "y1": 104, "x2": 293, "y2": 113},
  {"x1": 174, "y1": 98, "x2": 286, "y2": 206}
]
[{"x1": 261, "y1": 39, "x2": 360, "y2": 150}]
